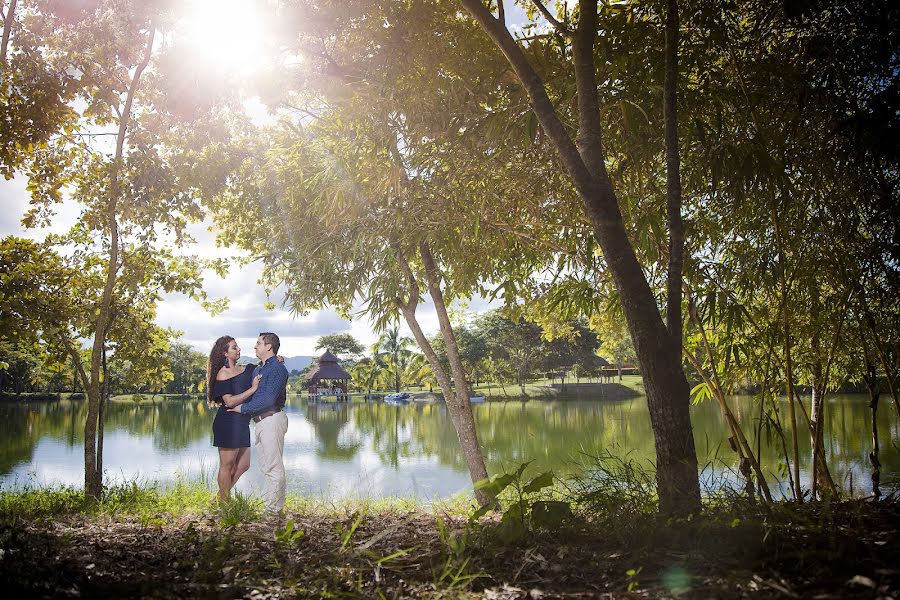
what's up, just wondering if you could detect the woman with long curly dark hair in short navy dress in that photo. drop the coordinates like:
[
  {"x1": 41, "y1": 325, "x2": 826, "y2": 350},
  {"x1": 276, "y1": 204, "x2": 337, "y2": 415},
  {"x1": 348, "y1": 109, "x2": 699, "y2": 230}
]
[{"x1": 206, "y1": 335, "x2": 261, "y2": 502}]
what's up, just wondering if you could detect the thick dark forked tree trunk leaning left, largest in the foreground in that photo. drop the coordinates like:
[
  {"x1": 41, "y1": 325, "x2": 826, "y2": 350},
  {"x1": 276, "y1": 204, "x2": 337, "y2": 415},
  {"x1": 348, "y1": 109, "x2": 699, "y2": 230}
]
[{"x1": 460, "y1": 0, "x2": 700, "y2": 515}]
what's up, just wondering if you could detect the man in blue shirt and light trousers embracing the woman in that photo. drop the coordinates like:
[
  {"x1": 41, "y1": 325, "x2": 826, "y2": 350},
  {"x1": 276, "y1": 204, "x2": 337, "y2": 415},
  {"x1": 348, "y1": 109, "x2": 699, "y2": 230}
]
[{"x1": 232, "y1": 332, "x2": 288, "y2": 515}]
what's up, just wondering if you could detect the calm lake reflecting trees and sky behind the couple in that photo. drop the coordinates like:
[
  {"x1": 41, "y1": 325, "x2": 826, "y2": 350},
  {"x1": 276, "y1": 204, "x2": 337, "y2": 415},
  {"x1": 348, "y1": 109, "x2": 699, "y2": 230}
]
[{"x1": 0, "y1": 395, "x2": 900, "y2": 500}]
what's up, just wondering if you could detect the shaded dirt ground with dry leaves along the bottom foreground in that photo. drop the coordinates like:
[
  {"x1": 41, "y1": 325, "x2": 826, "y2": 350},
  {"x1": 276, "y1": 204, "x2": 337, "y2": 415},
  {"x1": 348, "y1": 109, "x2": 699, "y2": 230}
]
[{"x1": 0, "y1": 502, "x2": 900, "y2": 599}]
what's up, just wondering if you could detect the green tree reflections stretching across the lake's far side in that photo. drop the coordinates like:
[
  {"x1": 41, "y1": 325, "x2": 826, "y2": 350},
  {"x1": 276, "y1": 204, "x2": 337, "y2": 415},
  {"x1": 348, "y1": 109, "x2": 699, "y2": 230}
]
[{"x1": 0, "y1": 396, "x2": 900, "y2": 494}]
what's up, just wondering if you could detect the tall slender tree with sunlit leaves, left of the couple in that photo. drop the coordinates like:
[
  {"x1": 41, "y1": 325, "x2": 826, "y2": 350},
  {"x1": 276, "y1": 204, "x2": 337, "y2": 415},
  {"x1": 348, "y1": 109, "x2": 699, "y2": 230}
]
[{"x1": 0, "y1": 0, "x2": 221, "y2": 498}]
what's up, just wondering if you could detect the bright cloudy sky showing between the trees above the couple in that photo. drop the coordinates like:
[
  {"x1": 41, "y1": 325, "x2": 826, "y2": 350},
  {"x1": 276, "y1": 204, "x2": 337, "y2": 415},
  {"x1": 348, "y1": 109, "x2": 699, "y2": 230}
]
[{"x1": 0, "y1": 176, "x2": 490, "y2": 357}]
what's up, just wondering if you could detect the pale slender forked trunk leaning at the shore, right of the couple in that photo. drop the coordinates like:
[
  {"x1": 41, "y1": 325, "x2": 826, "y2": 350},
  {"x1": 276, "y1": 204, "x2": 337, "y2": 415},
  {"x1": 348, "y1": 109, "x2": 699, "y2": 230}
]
[{"x1": 394, "y1": 242, "x2": 494, "y2": 506}]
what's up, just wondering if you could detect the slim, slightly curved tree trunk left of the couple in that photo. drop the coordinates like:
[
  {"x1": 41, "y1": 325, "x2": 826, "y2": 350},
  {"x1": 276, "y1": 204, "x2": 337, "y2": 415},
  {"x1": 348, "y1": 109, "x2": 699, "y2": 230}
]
[{"x1": 84, "y1": 27, "x2": 156, "y2": 500}]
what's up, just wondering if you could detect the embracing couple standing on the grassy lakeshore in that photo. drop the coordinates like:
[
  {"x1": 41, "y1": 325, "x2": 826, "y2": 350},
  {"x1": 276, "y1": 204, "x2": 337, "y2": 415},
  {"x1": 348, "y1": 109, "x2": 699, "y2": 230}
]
[{"x1": 206, "y1": 332, "x2": 288, "y2": 515}]
